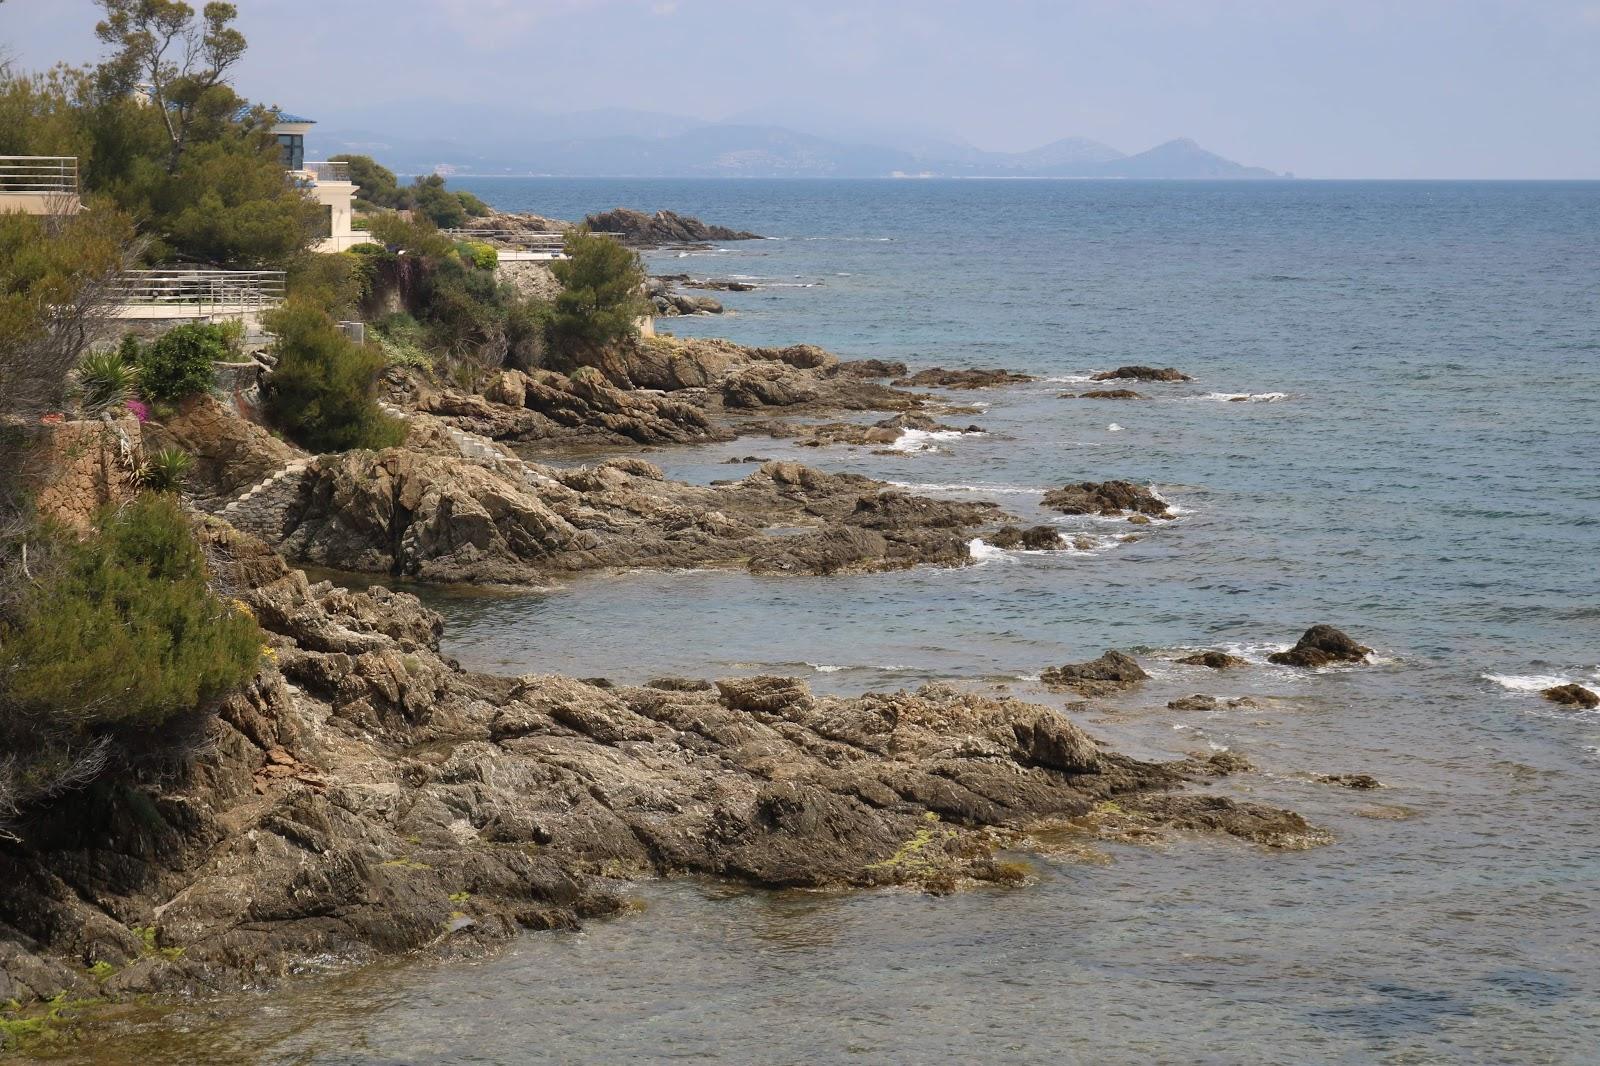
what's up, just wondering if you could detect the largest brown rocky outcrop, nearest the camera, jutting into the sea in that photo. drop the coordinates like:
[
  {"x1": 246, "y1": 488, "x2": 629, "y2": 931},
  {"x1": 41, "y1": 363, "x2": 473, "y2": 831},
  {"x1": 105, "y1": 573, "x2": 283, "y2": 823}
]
[{"x1": 0, "y1": 525, "x2": 1326, "y2": 1002}]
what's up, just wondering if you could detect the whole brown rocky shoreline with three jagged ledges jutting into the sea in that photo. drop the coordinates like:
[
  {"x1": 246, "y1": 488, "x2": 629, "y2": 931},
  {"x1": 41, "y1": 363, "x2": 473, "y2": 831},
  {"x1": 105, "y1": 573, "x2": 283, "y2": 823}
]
[{"x1": 0, "y1": 249, "x2": 1344, "y2": 1037}]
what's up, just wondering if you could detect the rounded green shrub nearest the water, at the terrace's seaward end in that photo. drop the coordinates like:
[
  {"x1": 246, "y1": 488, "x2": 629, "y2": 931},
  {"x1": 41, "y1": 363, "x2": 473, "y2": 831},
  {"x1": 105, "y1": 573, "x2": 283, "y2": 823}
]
[{"x1": 550, "y1": 230, "x2": 650, "y2": 354}]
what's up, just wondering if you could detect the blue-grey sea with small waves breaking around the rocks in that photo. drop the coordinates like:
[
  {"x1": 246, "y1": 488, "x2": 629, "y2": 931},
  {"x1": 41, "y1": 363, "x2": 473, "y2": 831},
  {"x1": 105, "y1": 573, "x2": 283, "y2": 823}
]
[{"x1": 78, "y1": 178, "x2": 1600, "y2": 1064}]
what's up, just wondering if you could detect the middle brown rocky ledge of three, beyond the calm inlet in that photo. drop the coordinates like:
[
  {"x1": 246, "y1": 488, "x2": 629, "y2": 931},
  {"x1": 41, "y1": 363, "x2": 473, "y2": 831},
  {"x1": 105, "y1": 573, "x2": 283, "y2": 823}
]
[{"x1": 235, "y1": 448, "x2": 1003, "y2": 584}]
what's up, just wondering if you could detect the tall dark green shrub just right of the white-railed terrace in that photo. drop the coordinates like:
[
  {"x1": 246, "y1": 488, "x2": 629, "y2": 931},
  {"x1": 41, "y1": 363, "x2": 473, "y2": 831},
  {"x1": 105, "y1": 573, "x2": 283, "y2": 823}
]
[{"x1": 266, "y1": 299, "x2": 406, "y2": 451}]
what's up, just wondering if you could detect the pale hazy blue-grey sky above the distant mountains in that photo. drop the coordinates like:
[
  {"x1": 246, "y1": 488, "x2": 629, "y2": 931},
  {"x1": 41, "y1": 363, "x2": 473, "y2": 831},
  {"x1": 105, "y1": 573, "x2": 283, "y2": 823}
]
[{"x1": 0, "y1": 0, "x2": 1600, "y2": 178}]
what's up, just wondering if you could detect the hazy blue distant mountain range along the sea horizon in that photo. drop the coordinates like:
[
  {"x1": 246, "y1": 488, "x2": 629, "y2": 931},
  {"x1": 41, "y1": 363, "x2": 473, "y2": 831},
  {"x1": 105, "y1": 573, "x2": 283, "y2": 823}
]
[{"x1": 300, "y1": 101, "x2": 1283, "y2": 178}]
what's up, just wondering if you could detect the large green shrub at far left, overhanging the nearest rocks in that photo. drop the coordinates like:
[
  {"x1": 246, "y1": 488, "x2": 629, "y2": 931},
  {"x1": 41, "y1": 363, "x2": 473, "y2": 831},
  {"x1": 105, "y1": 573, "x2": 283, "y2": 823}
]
[{"x1": 0, "y1": 495, "x2": 262, "y2": 733}]
